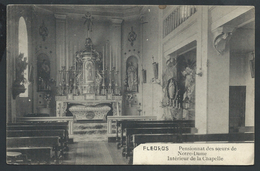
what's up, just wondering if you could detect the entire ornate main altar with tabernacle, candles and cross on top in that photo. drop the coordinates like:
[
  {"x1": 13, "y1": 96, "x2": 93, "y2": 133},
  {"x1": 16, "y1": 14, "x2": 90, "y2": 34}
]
[{"x1": 55, "y1": 13, "x2": 122, "y2": 121}]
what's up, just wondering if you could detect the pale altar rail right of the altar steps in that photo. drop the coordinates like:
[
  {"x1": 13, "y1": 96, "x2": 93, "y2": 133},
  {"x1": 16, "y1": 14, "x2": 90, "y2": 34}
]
[{"x1": 107, "y1": 116, "x2": 157, "y2": 136}]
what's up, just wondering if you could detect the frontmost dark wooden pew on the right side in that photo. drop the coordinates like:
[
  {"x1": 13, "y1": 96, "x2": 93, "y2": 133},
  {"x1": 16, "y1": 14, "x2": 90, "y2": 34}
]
[{"x1": 116, "y1": 120, "x2": 195, "y2": 148}]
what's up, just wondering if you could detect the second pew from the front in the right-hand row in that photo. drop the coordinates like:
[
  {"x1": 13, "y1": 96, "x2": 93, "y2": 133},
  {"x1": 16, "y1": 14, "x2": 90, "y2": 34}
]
[{"x1": 122, "y1": 126, "x2": 192, "y2": 157}]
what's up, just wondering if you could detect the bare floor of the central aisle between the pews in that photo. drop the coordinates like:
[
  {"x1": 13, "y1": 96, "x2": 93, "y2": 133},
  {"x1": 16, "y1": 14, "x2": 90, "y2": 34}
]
[{"x1": 62, "y1": 141, "x2": 127, "y2": 165}]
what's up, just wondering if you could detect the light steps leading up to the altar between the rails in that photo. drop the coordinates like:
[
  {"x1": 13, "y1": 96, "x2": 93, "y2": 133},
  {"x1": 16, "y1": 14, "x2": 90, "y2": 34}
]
[{"x1": 73, "y1": 121, "x2": 108, "y2": 142}]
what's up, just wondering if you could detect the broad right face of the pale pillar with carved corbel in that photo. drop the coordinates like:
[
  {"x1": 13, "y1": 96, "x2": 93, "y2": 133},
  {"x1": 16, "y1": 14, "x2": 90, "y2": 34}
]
[{"x1": 207, "y1": 16, "x2": 234, "y2": 134}]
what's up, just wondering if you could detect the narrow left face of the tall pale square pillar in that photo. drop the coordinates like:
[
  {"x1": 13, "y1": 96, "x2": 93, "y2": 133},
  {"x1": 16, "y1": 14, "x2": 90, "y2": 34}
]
[{"x1": 195, "y1": 7, "x2": 208, "y2": 134}]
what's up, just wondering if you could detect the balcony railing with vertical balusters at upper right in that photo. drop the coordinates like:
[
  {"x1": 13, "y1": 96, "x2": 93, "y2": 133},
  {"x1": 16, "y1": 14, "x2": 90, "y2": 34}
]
[{"x1": 163, "y1": 5, "x2": 197, "y2": 37}]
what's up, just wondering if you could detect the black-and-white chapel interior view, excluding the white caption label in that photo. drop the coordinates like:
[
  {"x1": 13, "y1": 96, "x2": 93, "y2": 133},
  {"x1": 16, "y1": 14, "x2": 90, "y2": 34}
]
[{"x1": 6, "y1": 5, "x2": 255, "y2": 165}]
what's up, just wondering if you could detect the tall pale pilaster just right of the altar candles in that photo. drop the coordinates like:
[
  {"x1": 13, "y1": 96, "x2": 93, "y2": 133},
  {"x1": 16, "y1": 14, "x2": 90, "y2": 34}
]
[{"x1": 111, "y1": 18, "x2": 123, "y2": 88}]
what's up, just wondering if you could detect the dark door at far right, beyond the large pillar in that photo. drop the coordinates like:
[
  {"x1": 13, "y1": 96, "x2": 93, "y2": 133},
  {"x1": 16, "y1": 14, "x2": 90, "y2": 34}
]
[{"x1": 229, "y1": 86, "x2": 246, "y2": 132}]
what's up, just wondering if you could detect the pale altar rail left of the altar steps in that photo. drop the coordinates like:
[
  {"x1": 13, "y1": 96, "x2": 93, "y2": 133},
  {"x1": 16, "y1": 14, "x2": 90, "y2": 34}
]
[{"x1": 16, "y1": 116, "x2": 73, "y2": 135}]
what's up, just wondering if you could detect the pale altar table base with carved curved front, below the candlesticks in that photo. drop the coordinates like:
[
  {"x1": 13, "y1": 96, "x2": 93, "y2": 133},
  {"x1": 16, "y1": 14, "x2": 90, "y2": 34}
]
[{"x1": 55, "y1": 95, "x2": 122, "y2": 120}]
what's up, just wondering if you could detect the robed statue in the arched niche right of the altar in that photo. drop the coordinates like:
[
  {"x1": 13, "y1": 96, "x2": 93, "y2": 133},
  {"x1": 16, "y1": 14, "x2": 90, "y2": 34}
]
[{"x1": 127, "y1": 62, "x2": 138, "y2": 92}]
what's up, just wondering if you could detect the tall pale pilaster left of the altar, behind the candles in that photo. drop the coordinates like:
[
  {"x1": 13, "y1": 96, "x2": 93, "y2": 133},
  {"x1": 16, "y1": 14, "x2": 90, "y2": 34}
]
[{"x1": 54, "y1": 14, "x2": 68, "y2": 84}]
